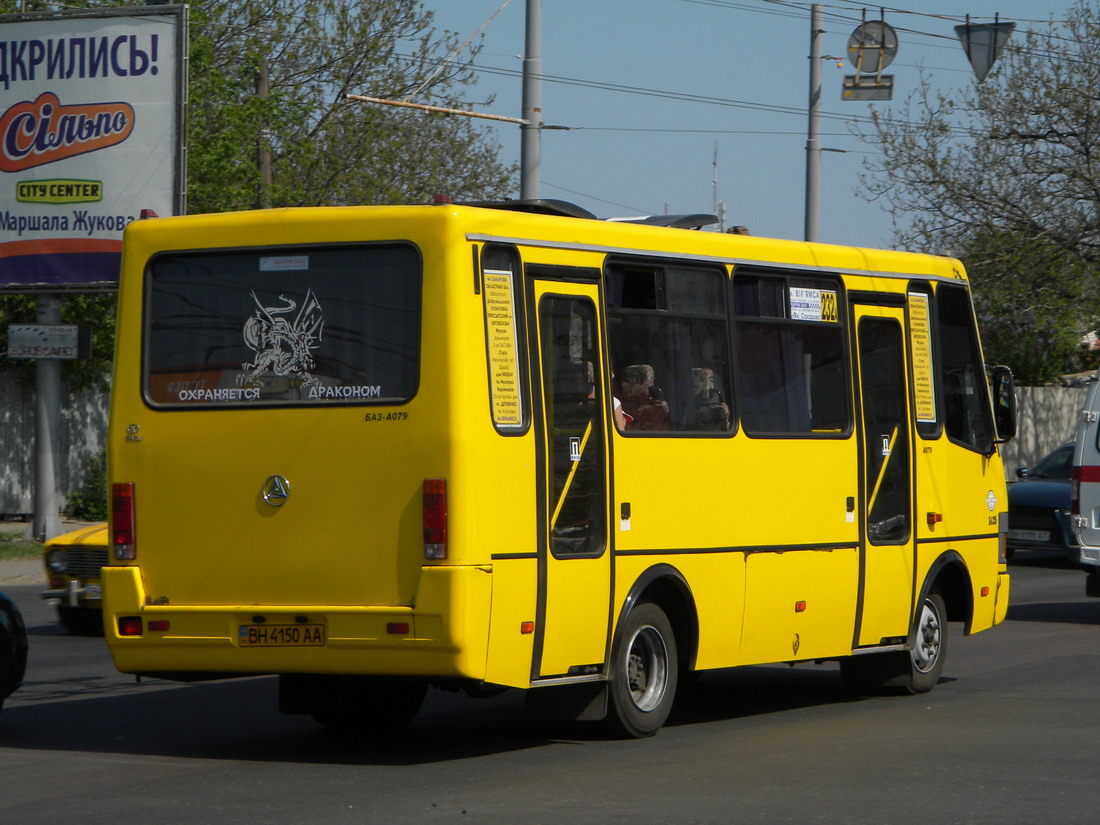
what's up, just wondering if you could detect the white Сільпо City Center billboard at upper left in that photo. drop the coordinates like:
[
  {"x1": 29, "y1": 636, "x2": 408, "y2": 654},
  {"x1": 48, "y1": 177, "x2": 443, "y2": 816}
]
[{"x1": 0, "y1": 6, "x2": 187, "y2": 292}]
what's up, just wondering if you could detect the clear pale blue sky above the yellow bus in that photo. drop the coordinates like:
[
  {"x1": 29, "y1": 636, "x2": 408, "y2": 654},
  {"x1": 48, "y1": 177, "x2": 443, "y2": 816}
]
[{"x1": 419, "y1": 0, "x2": 1071, "y2": 246}]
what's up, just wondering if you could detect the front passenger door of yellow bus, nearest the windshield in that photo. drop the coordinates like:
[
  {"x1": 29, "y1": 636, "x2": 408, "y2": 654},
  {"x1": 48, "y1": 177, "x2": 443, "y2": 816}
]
[{"x1": 855, "y1": 306, "x2": 915, "y2": 647}]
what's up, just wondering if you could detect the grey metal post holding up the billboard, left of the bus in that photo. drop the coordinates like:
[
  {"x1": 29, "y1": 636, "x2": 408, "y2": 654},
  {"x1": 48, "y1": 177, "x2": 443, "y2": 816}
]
[{"x1": 28, "y1": 295, "x2": 62, "y2": 541}]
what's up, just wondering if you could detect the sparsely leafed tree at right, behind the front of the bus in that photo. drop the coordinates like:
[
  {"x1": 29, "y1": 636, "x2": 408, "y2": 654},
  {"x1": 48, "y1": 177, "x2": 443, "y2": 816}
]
[{"x1": 861, "y1": 0, "x2": 1100, "y2": 384}]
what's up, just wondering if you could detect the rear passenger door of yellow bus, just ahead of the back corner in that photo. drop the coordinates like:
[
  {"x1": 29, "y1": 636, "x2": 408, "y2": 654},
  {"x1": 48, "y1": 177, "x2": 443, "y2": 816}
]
[{"x1": 528, "y1": 281, "x2": 612, "y2": 680}]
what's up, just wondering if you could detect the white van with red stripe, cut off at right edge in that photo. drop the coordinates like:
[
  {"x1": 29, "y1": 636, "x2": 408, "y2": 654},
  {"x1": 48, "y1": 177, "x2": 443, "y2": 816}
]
[{"x1": 1070, "y1": 381, "x2": 1100, "y2": 596}]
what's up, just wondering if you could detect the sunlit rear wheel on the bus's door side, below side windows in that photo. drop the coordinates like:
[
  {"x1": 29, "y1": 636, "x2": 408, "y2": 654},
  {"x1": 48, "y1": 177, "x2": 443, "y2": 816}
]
[{"x1": 604, "y1": 602, "x2": 679, "y2": 738}]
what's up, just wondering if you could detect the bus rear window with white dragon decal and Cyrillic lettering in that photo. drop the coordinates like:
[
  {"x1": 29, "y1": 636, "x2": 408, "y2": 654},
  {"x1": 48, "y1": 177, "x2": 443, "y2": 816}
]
[{"x1": 144, "y1": 244, "x2": 420, "y2": 407}]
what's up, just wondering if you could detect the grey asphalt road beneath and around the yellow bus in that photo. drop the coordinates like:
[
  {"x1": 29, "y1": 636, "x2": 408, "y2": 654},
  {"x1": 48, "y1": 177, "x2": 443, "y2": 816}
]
[{"x1": 0, "y1": 554, "x2": 1100, "y2": 825}]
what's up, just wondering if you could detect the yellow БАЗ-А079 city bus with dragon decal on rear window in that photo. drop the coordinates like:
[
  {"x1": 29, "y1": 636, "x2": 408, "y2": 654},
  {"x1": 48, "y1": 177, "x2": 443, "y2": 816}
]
[{"x1": 102, "y1": 201, "x2": 1014, "y2": 736}]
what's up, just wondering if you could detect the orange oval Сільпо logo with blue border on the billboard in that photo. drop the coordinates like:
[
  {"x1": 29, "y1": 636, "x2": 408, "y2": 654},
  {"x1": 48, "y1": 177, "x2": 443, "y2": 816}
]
[{"x1": 0, "y1": 91, "x2": 134, "y2": 172}]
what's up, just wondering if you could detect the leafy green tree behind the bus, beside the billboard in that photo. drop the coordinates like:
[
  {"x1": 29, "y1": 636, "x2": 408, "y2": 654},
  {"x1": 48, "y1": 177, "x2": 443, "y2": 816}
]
[{"x1": 188, "y1": 0, "x2": 516, "y2": 212}]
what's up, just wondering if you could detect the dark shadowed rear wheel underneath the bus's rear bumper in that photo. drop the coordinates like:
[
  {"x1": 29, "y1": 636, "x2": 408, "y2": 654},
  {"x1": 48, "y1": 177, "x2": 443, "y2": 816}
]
[{"x1": 309, "y1": 677, "x2": 428, "y2": 735}]
